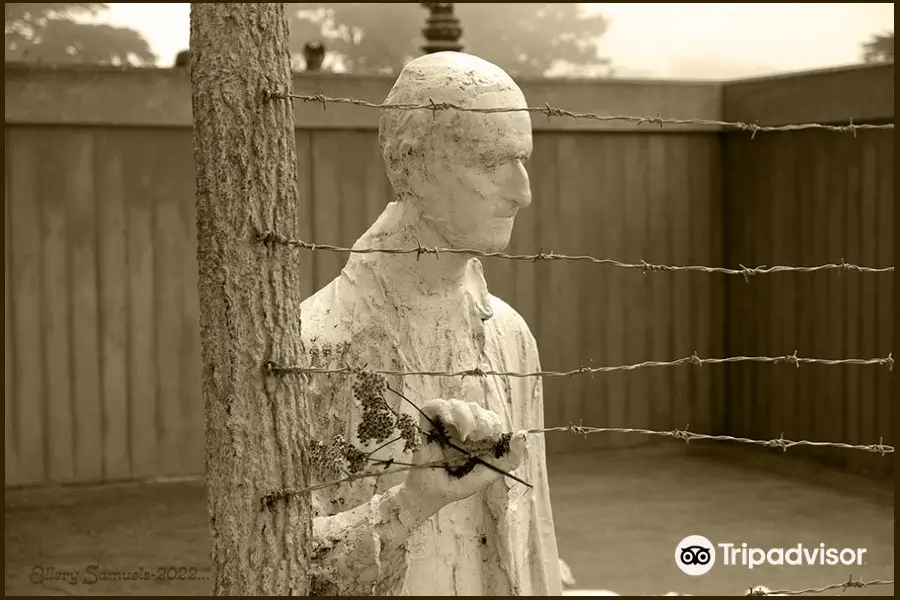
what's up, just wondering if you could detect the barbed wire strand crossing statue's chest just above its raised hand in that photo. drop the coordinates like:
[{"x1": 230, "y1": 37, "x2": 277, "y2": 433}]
[{"x1": 264, "y1": 350, "x2": 894, "y2": 378}]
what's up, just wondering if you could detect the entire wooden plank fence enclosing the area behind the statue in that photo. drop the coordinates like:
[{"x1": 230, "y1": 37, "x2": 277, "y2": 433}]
[{"x1": 5, "y1": 65, "x2": 893, "y2": 486}]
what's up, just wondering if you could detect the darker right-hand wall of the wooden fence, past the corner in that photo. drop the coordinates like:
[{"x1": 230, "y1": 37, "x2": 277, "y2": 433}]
[{"x1": 723, "y1": 65, "x2": 897, "y2": 474}]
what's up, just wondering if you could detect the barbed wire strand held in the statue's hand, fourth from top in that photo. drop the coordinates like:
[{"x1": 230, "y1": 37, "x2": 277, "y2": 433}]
[{"x1": 262, "y1": 424, "x2": 894, "y2": 506}]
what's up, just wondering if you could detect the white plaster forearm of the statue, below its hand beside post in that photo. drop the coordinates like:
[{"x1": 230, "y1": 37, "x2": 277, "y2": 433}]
[{"x1": 310, "y1": 483, "x2": 437, "y2": 596}]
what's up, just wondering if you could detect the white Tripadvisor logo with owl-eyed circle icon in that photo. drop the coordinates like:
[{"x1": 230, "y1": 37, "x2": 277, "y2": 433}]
[{"x1": 675, "y1": 535, "x2": 867, "y2": 576}]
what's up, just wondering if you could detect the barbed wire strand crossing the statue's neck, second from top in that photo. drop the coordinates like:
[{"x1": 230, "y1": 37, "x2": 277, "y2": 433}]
[{"x1": 259, "y1": 230, "x2": 894, "y2": 282}]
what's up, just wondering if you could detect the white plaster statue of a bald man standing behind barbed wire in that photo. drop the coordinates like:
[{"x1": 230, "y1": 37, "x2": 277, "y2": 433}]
[{"x1": 301, "y1": 52, "x2": 561, "y2": 595}]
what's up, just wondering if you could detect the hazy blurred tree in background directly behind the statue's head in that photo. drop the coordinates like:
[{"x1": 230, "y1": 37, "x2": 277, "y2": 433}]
[{"x1": 288, "y1": 3, "x2": 609, "y2": 76}]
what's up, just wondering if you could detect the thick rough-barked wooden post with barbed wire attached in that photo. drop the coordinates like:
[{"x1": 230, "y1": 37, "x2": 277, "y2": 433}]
[{"x1": 191, "y1": 3, "x2": 312, "y2": 595}]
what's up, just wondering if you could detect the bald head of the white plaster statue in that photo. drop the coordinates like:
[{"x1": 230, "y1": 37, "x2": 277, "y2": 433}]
[{"x1": 378, "y1": 52, "x2": 531, "y2": 253}]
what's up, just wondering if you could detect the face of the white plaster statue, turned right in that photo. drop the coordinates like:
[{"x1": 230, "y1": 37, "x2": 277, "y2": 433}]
[{"x1": 409, "y1": 90, "x2": 532, "y2": 252}]
